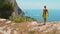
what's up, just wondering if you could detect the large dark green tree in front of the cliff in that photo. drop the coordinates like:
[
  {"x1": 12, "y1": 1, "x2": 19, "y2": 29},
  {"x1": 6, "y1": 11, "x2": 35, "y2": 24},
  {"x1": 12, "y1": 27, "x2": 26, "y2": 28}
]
[{"x1": 0, "y1": 2, "x2": 14, "y2": 19}]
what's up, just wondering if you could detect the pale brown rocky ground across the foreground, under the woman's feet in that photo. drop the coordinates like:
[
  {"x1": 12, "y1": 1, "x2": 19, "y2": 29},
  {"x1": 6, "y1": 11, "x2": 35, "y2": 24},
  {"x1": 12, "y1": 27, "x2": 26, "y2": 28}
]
[{"x1": 0, "y1": 19, "x2": 60, "y2": 34}]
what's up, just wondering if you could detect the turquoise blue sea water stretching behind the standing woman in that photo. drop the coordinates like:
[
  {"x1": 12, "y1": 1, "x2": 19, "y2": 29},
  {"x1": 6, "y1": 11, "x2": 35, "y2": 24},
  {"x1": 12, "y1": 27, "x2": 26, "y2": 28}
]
[{"x1": 24, "y1": 9, "x2": 60, "y2": 22}]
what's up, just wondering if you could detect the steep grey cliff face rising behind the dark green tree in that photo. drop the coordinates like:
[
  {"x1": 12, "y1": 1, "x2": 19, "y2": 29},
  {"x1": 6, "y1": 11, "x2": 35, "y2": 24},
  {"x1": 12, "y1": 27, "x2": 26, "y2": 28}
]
[{"x1": 0, "y1": 0, "x2": 24, "y2": 17}]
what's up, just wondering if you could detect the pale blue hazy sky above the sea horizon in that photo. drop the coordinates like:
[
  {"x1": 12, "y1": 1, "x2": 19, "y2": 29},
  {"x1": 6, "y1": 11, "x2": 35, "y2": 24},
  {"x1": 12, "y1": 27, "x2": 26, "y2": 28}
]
[{"x1": 16, "y1": 0, "x2": 60, "y2": 9}]
